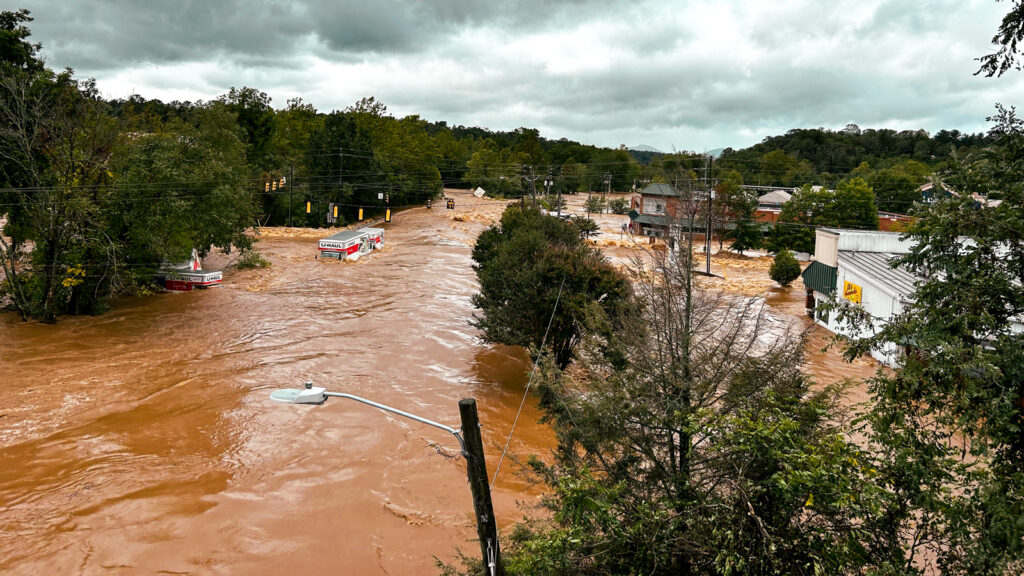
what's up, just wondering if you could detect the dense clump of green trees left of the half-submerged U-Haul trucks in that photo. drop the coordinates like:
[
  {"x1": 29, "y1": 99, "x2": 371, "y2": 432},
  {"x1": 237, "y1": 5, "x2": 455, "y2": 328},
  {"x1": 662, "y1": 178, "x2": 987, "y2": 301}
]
[{"x1": 0, "y1": 11, "x2": 254, "y2": 322}]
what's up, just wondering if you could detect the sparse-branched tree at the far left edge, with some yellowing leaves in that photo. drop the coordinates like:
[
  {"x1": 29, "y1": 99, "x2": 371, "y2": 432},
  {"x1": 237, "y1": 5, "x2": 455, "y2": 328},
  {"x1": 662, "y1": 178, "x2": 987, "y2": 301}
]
[{"x1": 0, "y1": 61, "x2": 119, "y2": 322}]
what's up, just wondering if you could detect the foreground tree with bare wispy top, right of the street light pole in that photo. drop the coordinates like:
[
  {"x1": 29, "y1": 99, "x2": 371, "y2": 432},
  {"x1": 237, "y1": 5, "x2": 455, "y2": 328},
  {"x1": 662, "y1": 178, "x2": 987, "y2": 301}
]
[{"x1": 505, "y1": 234, "x2": 878, "y2": 575}]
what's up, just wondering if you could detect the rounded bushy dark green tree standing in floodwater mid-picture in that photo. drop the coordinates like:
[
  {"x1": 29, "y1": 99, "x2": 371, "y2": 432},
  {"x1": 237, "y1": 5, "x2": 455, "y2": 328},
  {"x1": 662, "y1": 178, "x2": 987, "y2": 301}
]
[{"x1": 473, "y1": 204, "x2": 630, "y2": 367}]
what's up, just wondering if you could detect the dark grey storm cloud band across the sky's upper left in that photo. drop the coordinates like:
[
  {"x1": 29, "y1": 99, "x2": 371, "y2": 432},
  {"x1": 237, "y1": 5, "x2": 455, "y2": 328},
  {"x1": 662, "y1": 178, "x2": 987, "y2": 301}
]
[{"x1": 26, "y1": 0, "x2": 613, "y2": 70}]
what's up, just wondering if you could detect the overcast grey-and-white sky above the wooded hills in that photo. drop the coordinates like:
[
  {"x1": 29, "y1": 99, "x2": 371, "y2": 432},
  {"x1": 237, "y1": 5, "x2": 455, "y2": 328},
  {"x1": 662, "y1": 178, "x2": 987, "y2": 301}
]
[{"x1": 22, "y1": 0, "x2": 1024, "y2": 152}]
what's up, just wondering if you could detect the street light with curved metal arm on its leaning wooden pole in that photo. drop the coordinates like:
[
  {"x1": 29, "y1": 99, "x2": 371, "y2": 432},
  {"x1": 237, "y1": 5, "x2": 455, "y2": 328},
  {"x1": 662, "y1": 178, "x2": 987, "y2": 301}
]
[{"x1": 270, "y1": 382, "x2": 505, "y2": 576}]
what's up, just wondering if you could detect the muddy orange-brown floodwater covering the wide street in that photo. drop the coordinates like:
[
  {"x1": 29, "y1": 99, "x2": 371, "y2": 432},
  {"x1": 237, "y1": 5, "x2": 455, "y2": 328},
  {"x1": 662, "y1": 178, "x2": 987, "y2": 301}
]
[{"x1": 0, "y1": 189, "x2": 873, "y2": 575}]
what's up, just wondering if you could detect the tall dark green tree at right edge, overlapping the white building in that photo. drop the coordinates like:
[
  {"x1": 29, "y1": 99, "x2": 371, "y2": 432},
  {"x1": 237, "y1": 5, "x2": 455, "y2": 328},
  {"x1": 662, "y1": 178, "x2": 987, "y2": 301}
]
[{"x1": 844, "y1": 101, "x2": 1024, "y2": 575}]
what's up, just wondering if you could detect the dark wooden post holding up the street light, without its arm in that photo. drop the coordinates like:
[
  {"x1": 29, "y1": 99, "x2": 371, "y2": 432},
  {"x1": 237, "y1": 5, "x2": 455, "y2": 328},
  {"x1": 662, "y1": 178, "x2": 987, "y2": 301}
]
[{"x1": 459, "y1": 398, "x2": 505, "y2": 576}]
